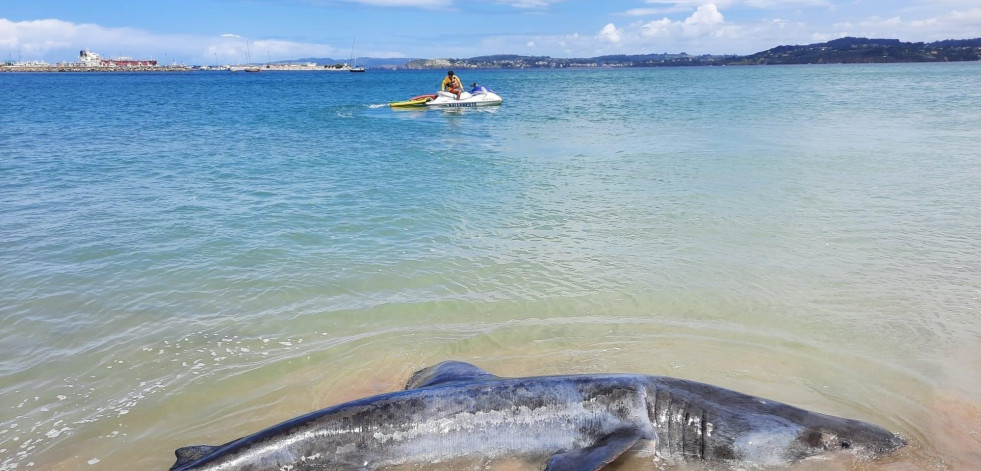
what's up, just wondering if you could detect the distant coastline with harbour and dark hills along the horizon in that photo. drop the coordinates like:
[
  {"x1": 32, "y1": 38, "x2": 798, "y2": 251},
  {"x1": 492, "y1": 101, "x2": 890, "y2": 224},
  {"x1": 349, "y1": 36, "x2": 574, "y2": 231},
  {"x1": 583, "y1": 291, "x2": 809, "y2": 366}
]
[{"x1": 0, "y1": 37, "x2": 981, "y2": 72}]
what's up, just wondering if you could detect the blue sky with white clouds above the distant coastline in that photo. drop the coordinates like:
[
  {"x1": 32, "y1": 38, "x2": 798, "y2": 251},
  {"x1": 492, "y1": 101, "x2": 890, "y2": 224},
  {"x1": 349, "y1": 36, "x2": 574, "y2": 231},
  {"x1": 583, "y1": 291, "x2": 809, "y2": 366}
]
[{"x1": 0, "y1": 0, "x2": 981, "y2": 64}]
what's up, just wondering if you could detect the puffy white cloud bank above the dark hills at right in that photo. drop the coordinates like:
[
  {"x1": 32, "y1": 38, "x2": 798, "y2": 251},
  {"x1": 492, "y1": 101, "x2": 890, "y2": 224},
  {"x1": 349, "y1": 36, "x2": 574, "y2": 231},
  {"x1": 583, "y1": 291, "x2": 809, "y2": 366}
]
[{"x1": 461, "y1": 0, "x2": 981, "y2": 57}]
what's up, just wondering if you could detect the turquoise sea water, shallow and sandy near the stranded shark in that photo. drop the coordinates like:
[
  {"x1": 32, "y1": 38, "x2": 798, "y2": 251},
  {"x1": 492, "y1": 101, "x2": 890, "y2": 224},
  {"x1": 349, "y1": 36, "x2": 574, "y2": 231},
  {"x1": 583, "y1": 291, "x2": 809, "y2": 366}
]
[{"x1": 0, "y1": 64, "x2": 981, "y2": 470}]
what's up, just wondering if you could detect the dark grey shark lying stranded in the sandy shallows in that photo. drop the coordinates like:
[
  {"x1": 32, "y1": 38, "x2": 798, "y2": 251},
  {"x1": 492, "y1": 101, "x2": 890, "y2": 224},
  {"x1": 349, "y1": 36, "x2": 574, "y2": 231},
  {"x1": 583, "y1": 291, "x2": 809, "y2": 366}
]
[{"x1": 170, "y1": 361, "x2": 905, "y2": 471}]
